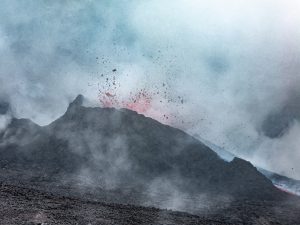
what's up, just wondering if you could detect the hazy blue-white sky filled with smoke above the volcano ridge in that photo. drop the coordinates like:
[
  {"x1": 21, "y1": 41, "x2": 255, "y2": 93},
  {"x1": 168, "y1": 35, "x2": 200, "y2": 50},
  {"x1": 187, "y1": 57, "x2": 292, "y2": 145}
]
[{"x1": 0, "y1": 0, "x2": 300, "y2": 179}]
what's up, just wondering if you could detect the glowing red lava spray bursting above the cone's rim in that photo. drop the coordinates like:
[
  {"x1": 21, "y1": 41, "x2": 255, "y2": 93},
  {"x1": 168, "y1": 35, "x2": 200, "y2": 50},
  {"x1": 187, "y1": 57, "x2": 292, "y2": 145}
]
[{"x1": 98, "y1": 74, "x2": 184, "y2": 125}]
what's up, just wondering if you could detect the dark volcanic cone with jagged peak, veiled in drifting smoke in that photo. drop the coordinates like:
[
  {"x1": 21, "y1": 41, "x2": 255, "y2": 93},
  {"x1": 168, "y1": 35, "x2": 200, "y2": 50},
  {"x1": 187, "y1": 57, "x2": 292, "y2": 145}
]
[{"x1": 0, "y1": 95, "x2": 284, "y2": 199}]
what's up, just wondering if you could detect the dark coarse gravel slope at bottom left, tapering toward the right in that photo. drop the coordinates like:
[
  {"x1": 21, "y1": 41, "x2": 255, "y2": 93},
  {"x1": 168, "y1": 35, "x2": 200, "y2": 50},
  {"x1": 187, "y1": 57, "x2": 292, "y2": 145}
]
[{"x1": 0, "y1": 182, "x2": 209, "y2": 225}]
